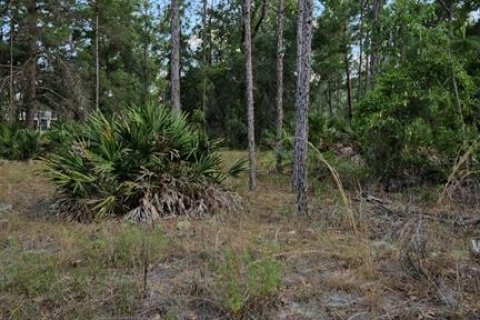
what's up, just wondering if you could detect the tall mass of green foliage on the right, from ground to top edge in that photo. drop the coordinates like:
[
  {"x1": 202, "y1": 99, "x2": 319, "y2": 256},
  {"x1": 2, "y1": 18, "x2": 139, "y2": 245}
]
[{"x1": 355, "y1": 1, "x2": 480, "y2": 183}]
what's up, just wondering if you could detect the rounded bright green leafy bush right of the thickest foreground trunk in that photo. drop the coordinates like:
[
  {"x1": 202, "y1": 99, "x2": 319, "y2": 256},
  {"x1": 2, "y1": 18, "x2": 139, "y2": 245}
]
[{"x1": 355, "y1": 65, "x2": 468, "y2": 185}]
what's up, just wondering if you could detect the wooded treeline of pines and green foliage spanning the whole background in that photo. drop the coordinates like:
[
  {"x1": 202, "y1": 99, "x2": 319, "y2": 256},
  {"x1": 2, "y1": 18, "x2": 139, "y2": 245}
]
[{"x1": 0, "y1": 0, "x2": 480, "y2": 210}]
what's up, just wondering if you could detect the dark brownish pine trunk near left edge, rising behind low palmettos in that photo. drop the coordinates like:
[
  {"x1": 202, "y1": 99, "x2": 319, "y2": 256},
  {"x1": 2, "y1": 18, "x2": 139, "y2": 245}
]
[{"x1": 26, "y1": 0, "x2": 37, "y2": 128}]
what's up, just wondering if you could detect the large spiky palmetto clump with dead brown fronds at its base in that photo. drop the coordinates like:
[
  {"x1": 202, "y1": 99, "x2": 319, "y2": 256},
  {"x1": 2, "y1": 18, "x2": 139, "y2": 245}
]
[{"x1": 45, "y1": 104, "x2": 243, "y2": 222}]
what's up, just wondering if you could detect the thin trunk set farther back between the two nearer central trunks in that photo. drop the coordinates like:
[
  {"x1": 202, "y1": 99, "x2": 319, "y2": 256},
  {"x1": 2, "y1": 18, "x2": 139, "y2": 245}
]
[{"x1": 275, "y1": 0, "x2": 285, "y2": 172}]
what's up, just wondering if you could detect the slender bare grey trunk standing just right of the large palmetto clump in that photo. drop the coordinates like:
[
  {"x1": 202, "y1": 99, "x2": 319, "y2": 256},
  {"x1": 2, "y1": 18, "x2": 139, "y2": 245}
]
[{"x1": 242, "y1": 0, "x2": 256, "y2": 191}]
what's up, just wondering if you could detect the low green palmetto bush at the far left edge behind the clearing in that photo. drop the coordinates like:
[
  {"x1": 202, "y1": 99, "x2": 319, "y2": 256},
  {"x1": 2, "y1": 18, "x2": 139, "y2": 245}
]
[{"x1": 0, "y1": 124, "x2": 42, "y2": 161}]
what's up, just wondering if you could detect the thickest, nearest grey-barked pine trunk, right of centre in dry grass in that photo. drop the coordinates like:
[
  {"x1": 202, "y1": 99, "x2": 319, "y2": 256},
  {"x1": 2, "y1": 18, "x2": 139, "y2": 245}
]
[{"x1": 294, "y1": 0, "x2": 313, "y2": 214}]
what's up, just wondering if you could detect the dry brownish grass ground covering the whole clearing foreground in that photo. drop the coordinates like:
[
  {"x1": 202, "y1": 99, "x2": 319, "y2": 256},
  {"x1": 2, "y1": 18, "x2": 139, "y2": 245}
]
[{"x1": 0, "y1": 152, "x2": 480, "y2": 320}]
